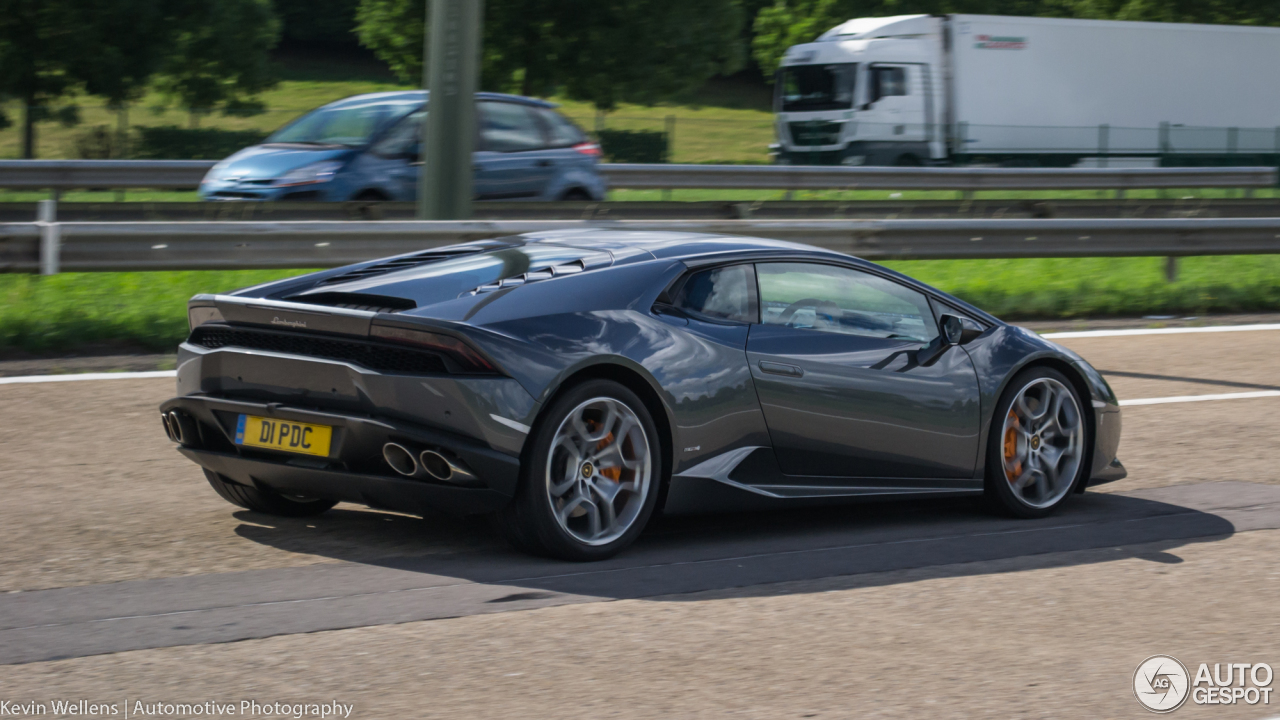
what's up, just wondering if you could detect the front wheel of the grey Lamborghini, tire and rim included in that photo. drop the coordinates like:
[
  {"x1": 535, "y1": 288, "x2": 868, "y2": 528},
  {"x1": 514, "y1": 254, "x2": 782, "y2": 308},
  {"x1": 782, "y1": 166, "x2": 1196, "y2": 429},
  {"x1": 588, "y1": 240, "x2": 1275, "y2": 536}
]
[{"x1": 987, "y1": 368, "x2": 1088, "y2": 518}]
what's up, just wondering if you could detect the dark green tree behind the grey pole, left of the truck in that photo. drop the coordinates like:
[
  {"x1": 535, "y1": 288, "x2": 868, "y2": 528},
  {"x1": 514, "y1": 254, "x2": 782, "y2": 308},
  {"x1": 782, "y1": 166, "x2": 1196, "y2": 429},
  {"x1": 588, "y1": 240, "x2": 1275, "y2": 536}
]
[{"x1": 356, "y1": 0, "x2": 745, "y2": 110}]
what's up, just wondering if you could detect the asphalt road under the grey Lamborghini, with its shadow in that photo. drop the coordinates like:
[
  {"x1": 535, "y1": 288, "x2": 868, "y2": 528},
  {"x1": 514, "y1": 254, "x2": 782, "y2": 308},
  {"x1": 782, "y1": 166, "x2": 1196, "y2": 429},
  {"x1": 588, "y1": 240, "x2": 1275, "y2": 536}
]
[{"x1": 0, "y1": 331, "x2": 1280, "y2": 717}]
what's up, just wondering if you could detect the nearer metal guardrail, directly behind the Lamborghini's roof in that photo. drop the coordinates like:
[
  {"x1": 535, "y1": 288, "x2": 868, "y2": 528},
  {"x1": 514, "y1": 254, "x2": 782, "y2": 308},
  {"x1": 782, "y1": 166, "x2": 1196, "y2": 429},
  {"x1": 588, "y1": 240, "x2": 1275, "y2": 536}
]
[{"x1": 0, "y1": 218, "x2": 1280, "y2": 273}]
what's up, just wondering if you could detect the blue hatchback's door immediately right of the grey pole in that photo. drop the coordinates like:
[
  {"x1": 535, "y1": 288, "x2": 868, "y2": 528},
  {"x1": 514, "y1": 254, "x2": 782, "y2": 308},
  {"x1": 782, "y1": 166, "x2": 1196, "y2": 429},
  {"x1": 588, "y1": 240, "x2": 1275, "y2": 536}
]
[{"x1": 475, "y1": 100, "x2": 554, "y2": 200}]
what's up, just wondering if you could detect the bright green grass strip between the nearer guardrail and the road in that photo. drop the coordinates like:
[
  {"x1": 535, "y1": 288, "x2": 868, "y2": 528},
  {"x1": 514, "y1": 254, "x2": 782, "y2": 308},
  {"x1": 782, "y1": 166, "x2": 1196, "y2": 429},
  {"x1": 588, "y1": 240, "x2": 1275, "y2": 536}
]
[{"x1": 0, "y1": 256, "x2": 1280, "y2": 356}]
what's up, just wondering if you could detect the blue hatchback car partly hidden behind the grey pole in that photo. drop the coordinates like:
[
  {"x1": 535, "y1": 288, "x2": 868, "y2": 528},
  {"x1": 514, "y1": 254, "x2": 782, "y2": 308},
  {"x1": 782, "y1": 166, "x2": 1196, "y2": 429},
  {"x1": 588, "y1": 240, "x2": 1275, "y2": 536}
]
[{"x1": 200, "y1": 91, "x2": 605, "y2": 202}]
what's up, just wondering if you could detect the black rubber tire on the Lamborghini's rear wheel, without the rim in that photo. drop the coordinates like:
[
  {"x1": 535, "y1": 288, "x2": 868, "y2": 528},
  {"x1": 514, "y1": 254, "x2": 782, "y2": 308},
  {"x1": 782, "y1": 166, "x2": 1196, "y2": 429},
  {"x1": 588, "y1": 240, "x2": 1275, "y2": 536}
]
[{"x1": 494, "y1": 379, "x2": 666, "y2": 561}]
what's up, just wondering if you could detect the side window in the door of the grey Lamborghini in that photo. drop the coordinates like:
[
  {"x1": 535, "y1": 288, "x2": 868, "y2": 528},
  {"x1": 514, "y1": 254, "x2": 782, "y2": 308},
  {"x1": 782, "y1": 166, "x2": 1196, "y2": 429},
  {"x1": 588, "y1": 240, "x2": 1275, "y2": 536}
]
[{"x1": 755, "y1": 263, "x2": 938, "y2": 342}]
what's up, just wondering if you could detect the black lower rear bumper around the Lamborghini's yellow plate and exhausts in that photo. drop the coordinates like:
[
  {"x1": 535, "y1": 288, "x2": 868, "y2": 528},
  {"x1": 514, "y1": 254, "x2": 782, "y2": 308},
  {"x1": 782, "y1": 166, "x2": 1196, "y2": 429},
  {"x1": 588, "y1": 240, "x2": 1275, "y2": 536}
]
[{"x1": 160, "y1": 395, "x2": 520, "y2": 515}]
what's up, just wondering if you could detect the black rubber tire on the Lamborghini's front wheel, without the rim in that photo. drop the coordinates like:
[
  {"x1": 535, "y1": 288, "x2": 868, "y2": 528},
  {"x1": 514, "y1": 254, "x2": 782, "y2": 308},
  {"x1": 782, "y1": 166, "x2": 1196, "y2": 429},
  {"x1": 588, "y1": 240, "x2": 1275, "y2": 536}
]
[{"x1": 986, "y1": 366, "x2": 1089, "y2": 519}]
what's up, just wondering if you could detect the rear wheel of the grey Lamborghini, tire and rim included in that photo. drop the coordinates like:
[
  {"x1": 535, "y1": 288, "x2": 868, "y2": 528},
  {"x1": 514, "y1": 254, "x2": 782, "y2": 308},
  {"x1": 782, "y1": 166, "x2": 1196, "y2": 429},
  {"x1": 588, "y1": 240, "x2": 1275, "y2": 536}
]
[{"x1": 498, "y1": 380, "x2": 663, "y2": 560}]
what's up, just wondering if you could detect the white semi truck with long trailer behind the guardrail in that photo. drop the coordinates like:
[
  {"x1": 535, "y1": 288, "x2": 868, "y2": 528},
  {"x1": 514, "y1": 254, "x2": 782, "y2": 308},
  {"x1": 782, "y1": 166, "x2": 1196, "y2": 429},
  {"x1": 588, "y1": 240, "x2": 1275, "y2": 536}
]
[{"x1": 772, "y1": 15, "x2": 1280, "y2": 167}]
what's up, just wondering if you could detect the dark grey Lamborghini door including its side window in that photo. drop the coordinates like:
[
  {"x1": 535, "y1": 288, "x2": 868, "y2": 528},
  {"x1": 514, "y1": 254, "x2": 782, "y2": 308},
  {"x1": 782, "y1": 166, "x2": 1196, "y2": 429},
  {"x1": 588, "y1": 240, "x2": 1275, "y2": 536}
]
[{"x1": 746, "y1": 263, "x2": 980, "y2": 486}]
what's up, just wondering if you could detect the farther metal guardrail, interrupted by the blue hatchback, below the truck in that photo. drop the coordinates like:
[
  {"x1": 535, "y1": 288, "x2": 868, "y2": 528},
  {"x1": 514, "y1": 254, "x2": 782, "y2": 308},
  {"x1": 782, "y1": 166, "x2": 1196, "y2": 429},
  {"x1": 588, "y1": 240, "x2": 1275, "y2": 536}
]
[{"x1": 0, "y1": 160, "x2": 1276, "y2": 192}]
